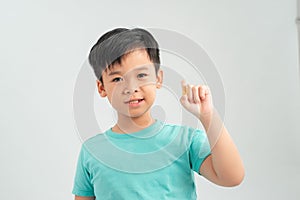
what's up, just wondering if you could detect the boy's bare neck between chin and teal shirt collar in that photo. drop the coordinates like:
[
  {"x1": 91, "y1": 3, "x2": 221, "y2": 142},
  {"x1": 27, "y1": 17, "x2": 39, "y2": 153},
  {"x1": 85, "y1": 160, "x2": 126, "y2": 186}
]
[{"x1": 112, "y1": 115, "x2": 155, "y2": 134}]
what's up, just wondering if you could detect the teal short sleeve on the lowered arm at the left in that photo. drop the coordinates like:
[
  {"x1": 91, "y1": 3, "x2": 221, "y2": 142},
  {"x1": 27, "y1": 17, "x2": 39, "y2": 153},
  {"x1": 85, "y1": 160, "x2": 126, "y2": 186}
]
[{"x1": 72, "y1": 146, "x2": 95, "y2": 196}]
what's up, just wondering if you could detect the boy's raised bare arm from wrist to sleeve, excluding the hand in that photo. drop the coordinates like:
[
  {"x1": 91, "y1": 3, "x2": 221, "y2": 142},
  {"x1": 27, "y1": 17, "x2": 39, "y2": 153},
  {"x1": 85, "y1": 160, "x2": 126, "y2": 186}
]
[{"x1": 200, "y1": 111, "x2": 244, "y2": 186}]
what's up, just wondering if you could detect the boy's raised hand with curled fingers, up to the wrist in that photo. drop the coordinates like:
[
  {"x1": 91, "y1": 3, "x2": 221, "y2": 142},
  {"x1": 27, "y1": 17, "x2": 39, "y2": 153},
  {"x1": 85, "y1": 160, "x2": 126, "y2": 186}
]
[{"x1": 180, "y1": 81, "x2": 213, "y2": 121}]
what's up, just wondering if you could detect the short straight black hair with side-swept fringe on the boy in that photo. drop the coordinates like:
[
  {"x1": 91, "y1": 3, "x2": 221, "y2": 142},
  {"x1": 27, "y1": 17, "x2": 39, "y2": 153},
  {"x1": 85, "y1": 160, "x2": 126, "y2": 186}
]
[{"x1": 88, "y1": 28, "x2": 160, "y2": 83}]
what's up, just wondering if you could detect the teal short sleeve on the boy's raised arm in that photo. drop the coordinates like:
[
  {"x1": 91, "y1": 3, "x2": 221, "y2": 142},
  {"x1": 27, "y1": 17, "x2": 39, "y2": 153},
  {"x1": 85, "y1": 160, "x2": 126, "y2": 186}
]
[{"x1": 189, "y1": 129, "x2": 211, "y2": 174}]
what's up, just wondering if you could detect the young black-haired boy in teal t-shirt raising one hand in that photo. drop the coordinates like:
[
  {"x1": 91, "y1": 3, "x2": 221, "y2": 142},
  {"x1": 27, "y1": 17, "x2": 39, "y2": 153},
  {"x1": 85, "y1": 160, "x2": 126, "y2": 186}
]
[{"x1": 73, "y1": 28, "x2": 244, "y2": 200}]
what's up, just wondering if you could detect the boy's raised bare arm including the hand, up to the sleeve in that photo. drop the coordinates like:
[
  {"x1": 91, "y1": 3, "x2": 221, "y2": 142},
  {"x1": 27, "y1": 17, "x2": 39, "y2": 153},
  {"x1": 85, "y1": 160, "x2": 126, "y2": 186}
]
[{"x1": 180, "y1": 82, "x2": 244, "y2": 186}]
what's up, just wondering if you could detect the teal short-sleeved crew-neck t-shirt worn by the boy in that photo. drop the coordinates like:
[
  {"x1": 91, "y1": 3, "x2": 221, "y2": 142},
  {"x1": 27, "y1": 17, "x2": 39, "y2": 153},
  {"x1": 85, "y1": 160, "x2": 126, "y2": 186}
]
[{"x1": 73, "y1": 120, "x2": 210, "y2": 200}]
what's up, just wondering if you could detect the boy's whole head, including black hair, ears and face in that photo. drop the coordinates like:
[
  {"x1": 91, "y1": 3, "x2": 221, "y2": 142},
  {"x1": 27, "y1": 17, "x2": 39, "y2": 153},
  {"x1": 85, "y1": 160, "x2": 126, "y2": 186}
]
[{"x1": 89, "y1": 28, "x2": 163, "y2": 117}]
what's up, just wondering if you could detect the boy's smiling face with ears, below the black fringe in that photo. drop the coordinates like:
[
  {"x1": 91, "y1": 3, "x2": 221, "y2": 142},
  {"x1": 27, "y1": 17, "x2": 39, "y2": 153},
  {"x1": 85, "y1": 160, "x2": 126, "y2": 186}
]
[{"x1": 97, "y1": 50, "x2": 163, "y2": 117}]
